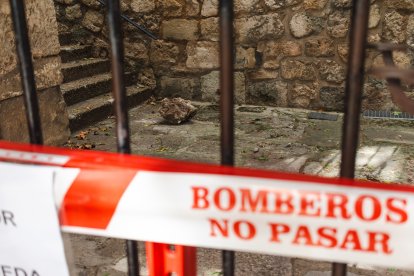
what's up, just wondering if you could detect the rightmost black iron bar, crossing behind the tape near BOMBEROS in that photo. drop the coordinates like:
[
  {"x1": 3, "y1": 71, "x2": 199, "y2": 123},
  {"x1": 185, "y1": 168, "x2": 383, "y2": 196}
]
[{"x1": 332, "y1": 0, "x2": 370, "y2": 276}]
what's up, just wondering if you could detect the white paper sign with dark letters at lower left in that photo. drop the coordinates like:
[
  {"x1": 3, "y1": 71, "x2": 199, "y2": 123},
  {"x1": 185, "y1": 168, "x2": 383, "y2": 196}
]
[{"x1": 0, "y1": 163, "x2": 69, "y2": 276}]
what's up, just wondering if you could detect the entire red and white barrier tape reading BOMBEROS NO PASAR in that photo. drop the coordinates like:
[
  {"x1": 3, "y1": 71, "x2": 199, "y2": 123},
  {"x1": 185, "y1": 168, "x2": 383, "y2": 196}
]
[{"x1": 0, "y1": 142, "x2": 414, "y2": 269}]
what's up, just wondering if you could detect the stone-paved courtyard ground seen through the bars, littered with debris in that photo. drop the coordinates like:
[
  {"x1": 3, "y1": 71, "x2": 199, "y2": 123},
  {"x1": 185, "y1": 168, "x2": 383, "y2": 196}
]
[{"x1": 65, "y1": 101, "x2": 414, "y2": 276}]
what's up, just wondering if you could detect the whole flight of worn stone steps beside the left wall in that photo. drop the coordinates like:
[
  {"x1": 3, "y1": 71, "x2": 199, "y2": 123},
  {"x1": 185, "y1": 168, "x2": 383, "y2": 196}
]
[{"x1": 59, "y1": 33, "x2": 153, "y2": 132}]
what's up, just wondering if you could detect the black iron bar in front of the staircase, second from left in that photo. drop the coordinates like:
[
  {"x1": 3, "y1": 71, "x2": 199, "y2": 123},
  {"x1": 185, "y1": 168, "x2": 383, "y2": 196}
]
[{"x1": 108, "y1": 0, "x2": 139, "y2": 276}]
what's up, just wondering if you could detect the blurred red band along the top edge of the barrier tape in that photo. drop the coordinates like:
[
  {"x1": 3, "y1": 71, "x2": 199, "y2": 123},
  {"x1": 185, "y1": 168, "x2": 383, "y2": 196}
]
[{"x1": 0, "y1": 141, "x2": 414, "y2": 193}]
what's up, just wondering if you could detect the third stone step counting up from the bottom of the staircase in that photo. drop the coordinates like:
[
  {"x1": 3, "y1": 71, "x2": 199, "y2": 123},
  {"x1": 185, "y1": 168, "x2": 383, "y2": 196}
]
[{"x1": 62, "y1": 58, "x2": 111, "y2": 83}]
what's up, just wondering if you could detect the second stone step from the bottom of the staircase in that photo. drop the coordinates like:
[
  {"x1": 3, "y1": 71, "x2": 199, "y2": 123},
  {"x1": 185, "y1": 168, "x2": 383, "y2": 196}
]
[{"x1": 60, "y1": 73, "x2": 134, "y2": 106}]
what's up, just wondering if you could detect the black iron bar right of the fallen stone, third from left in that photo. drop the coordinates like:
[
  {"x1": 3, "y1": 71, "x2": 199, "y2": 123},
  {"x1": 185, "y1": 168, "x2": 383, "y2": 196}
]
[{"x1": 219, "y1": 0, "x2": 234, "y2": 276}]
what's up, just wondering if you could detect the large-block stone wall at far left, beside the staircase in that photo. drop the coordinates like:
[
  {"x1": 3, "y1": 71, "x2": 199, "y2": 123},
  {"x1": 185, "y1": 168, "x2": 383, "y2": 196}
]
[{"x1": 0, "y1": 0, "x2": 69, "y2": 145}]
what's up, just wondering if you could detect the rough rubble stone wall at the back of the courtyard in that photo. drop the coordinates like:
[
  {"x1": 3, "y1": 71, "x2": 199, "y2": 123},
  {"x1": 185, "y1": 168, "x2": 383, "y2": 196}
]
[{"x1": 55, "y1": 0, "x2": 414, "y2": 110}]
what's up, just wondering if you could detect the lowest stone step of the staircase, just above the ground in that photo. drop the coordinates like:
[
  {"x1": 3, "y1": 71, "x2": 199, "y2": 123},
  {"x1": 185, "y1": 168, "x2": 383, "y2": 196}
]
[{"x1": 68, "y1": 86, "x2": 153, "y2": 132}]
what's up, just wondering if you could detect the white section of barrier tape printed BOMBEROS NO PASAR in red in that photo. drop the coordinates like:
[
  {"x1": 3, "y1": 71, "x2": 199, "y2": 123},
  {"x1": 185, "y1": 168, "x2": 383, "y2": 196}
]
[{"x1": 59, "y1": 171, "x2": 414, "y2": 269}]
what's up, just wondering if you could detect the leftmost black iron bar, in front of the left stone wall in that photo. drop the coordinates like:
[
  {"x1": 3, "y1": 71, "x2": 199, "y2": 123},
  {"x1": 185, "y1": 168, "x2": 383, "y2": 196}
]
[{"x1": 10, "y1": 0, "x2": 43, "y2": 145}]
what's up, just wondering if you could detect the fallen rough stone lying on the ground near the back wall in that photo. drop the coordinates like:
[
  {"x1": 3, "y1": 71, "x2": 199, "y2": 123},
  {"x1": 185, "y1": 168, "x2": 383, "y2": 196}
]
[{"x1": 159, "y1": 98, "x2": 197, "y2": 125}]
